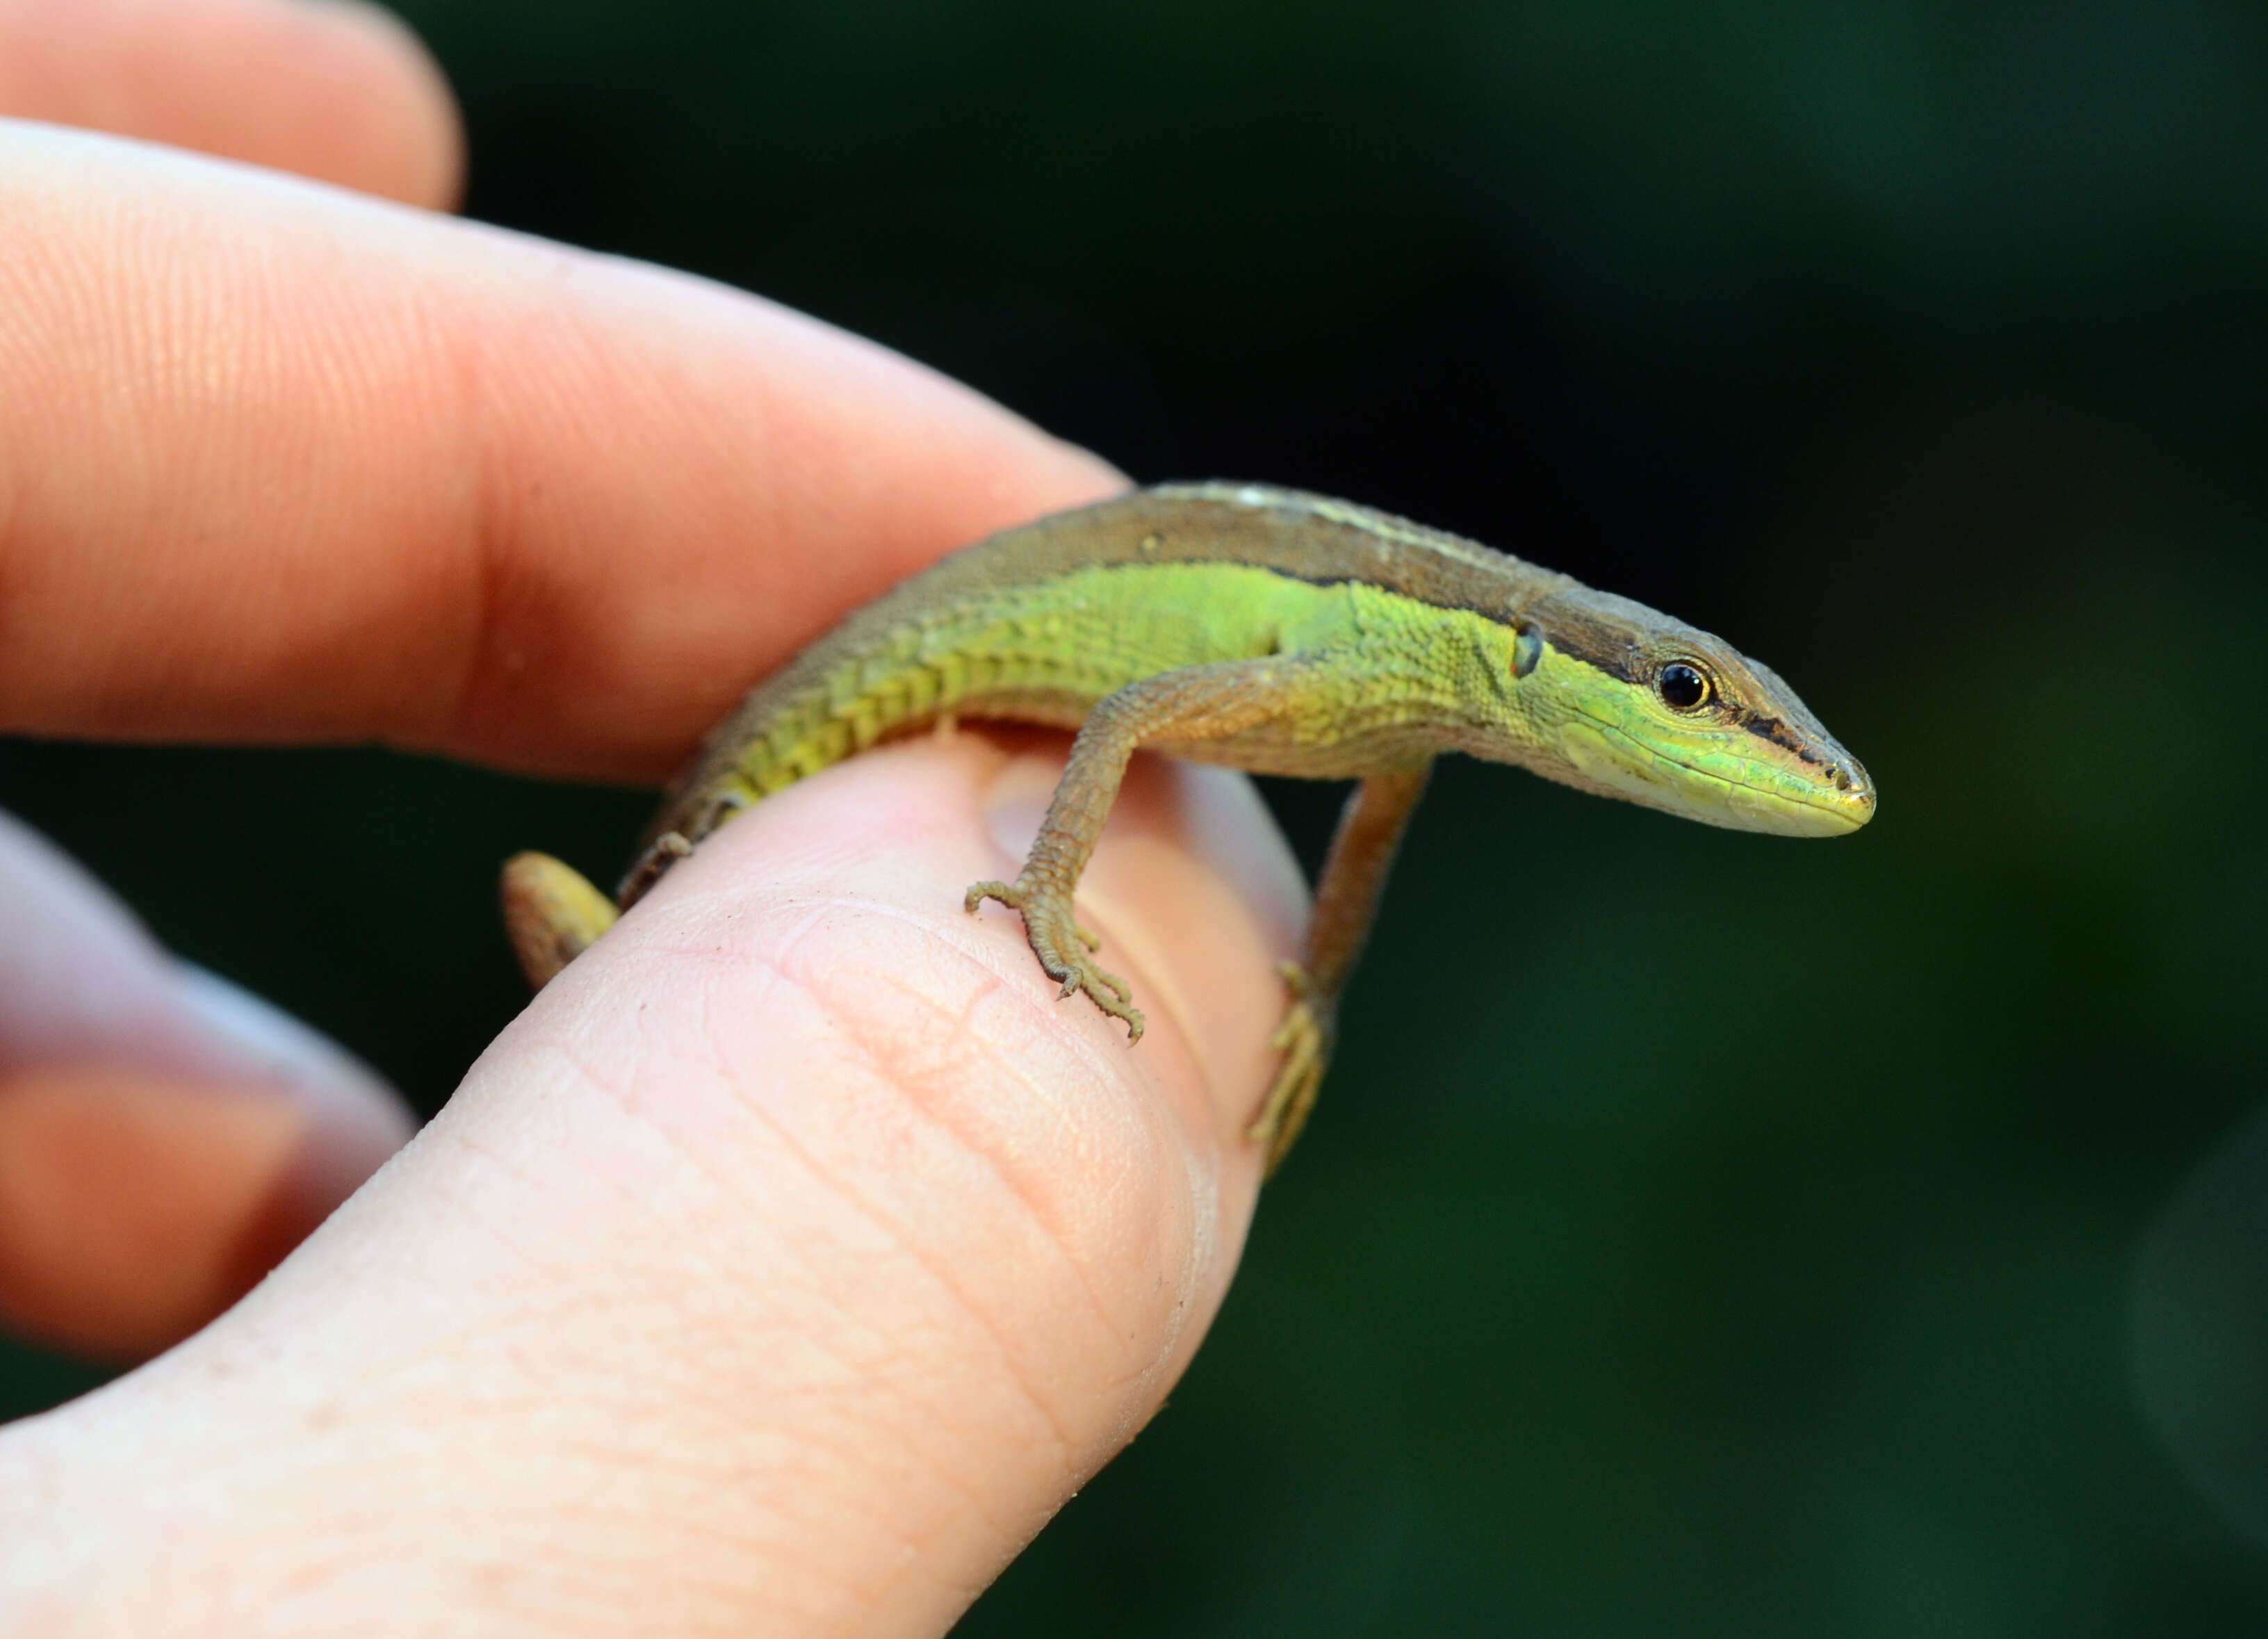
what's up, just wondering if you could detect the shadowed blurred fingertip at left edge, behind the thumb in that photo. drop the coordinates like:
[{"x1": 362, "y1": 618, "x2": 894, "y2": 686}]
[{"x1": 0, "y1": 814, "x2": 411, "y2": 1360}]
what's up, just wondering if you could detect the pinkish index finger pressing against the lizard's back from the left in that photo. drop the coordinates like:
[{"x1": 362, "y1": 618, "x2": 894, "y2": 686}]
[{"x1": 0, "y1": 122, "x2": 1123, "y2": 778}]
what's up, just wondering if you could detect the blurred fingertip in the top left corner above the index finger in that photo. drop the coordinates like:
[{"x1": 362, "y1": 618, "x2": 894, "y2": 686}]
[{"x1": 0, "y1": 0, "x2": 465, "y2": 211}]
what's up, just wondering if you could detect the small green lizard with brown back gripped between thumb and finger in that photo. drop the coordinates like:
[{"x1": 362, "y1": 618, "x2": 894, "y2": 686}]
[{"x1": 503, "y1": 483, "x2": 1873, "y2": 1168}]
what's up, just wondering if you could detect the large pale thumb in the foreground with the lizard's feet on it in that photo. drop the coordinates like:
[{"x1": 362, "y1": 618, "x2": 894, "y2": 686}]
[{"x1": 0, "y1": 735, "x2": 1297, "y2": 1637}]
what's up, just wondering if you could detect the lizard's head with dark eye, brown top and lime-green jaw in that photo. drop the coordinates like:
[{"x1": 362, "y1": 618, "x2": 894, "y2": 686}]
[{"x1": 1506, "y1": 585, "x2": 1873, "y2": 836}]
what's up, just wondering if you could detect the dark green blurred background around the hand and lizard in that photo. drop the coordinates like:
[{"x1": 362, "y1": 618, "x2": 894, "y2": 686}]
[{"x1": 0, "y1": 0, "x2": 2268, "y2": 1637}]
